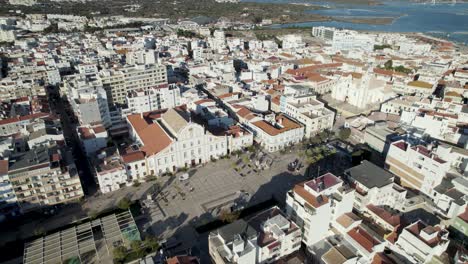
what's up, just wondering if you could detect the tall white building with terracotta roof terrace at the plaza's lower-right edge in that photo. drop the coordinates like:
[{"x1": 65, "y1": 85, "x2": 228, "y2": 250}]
[{"x1": 286, "y1": 173, "x2": 354, "y2": 247}]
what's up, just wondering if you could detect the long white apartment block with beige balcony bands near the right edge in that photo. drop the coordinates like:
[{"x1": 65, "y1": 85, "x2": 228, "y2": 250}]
[{"x1": 385, "y1": 140, "x2": 450, "y2": 196}]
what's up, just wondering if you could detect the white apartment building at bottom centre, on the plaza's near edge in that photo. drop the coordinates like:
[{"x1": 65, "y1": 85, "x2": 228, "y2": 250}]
[{"x1": 208, "y1": 207, "x2": 301, "y2": 264}]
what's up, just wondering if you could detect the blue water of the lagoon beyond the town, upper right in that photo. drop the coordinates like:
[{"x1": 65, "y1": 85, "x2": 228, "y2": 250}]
[{"x1": 243, "y1": 0, "x2": 468, "y2": 44}]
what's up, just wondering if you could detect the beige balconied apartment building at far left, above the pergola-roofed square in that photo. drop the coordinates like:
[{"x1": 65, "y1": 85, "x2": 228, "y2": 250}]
[{"x1": 8, "y1": 145, "x2": 83, "y2": 212}]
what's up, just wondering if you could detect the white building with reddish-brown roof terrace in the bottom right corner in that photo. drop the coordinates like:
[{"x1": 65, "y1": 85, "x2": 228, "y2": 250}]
[{"x1": 395, "y1": 220, "x2": 450, "y2": 263}]
